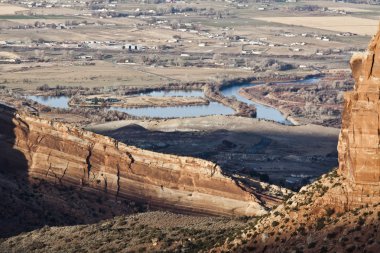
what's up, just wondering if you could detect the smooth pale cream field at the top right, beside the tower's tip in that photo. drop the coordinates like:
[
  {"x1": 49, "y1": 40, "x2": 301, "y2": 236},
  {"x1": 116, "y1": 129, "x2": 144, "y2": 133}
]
[{"x1": 255, "y1": 16, "x2": 379, "y2": 35}]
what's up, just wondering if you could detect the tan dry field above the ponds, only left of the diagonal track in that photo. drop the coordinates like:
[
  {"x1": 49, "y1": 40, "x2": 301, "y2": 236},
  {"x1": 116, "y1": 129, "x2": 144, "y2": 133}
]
[{"x1": 1, "y1": 61, "x2": 168, "y2": 89}]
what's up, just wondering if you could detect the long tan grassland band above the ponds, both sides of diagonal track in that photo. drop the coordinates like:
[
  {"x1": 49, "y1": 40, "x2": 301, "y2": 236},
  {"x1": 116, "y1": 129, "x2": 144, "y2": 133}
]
[{"x1": 0, "y1": 61, "x2": 252, "y2": 90}]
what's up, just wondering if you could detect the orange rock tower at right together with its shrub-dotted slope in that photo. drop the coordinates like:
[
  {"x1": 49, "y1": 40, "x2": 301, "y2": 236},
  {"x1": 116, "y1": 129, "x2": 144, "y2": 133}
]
[{"x1": 218, "y1": 24, "x2": 380, "y2": 252}]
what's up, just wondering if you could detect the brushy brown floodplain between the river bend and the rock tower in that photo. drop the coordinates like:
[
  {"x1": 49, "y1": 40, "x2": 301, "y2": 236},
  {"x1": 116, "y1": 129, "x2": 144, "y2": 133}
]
[{"x1": 239, "y1": 72, "x2": 353, "y2": 128}]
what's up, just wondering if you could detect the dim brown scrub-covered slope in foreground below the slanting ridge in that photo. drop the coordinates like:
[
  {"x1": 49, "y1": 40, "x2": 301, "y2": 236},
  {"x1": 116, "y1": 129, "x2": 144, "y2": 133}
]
[{"x1": 0, "y1": 212, "x2": 246, "y2": 253}]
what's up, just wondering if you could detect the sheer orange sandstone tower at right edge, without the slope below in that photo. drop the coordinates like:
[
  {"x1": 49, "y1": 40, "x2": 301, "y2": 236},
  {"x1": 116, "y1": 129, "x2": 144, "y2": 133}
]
[{"x1": 335, "y1": 26, "x2": 380, "y2": 207}]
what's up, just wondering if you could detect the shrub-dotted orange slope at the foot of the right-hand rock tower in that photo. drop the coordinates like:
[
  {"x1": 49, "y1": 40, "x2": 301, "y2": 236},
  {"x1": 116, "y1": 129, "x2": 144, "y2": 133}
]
[{"x1": 221, "y1": 170, "x2": 380, "y2": 253}]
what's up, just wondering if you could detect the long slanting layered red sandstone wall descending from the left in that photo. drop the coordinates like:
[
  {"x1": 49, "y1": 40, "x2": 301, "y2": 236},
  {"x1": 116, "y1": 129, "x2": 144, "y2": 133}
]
[{"x1": 0, "y1": 107, "x2": 266, "y2": 215}]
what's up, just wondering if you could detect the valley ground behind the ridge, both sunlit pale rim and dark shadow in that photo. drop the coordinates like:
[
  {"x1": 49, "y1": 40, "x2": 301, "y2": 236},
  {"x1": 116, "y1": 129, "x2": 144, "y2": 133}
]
[{"x1": 88, "y1": 116, "x2": 339, "y2": 188}]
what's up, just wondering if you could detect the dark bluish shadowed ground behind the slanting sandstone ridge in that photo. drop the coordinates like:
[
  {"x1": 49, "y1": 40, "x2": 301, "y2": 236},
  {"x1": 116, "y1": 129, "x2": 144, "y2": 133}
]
[{"x1": 95, "y1": 124, "x2": 338, "y2": 190}]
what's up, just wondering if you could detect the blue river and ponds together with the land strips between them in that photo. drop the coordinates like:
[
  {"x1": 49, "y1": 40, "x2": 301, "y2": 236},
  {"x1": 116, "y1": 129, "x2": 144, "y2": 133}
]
[{"x1": 14, "y1": 73, "x2": 321, "y2": 125}]
